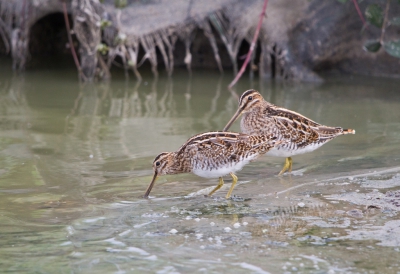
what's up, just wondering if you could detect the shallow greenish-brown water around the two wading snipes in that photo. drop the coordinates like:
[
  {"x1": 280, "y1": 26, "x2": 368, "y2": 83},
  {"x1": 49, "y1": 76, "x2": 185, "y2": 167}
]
[{"x1": 0, "y1": 60, "x2": 400, "y2": 273}]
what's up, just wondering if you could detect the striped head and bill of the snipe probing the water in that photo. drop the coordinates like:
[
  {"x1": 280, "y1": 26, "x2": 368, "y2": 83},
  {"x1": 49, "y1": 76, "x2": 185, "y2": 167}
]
[{"x1": 143, "y1": 152, "x2": 178, "y2": 198}]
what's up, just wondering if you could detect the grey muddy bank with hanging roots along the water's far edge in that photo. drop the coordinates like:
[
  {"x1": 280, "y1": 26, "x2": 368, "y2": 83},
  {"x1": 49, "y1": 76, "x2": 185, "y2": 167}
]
[{"x1": 0, "y1": 0, "x2": 400, "y2": 81}]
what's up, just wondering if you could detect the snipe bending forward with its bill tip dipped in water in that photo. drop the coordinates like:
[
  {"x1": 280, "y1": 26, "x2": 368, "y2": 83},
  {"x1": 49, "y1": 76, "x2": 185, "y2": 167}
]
[{"x1": 143, "y1": 132, "x2": 282, "y2": 199}]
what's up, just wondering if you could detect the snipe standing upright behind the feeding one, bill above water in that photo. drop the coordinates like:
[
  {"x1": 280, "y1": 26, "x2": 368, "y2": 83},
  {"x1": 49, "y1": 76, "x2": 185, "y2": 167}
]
[{"x1": 224, "y1": 89, "x2": 355, "y2": 175}]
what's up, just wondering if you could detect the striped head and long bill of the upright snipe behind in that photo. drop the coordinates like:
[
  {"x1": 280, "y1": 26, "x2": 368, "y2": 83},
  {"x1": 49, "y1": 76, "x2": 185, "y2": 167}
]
[{"x1": 223, "y1": 89, "x2": 265, "y2": 131}]
